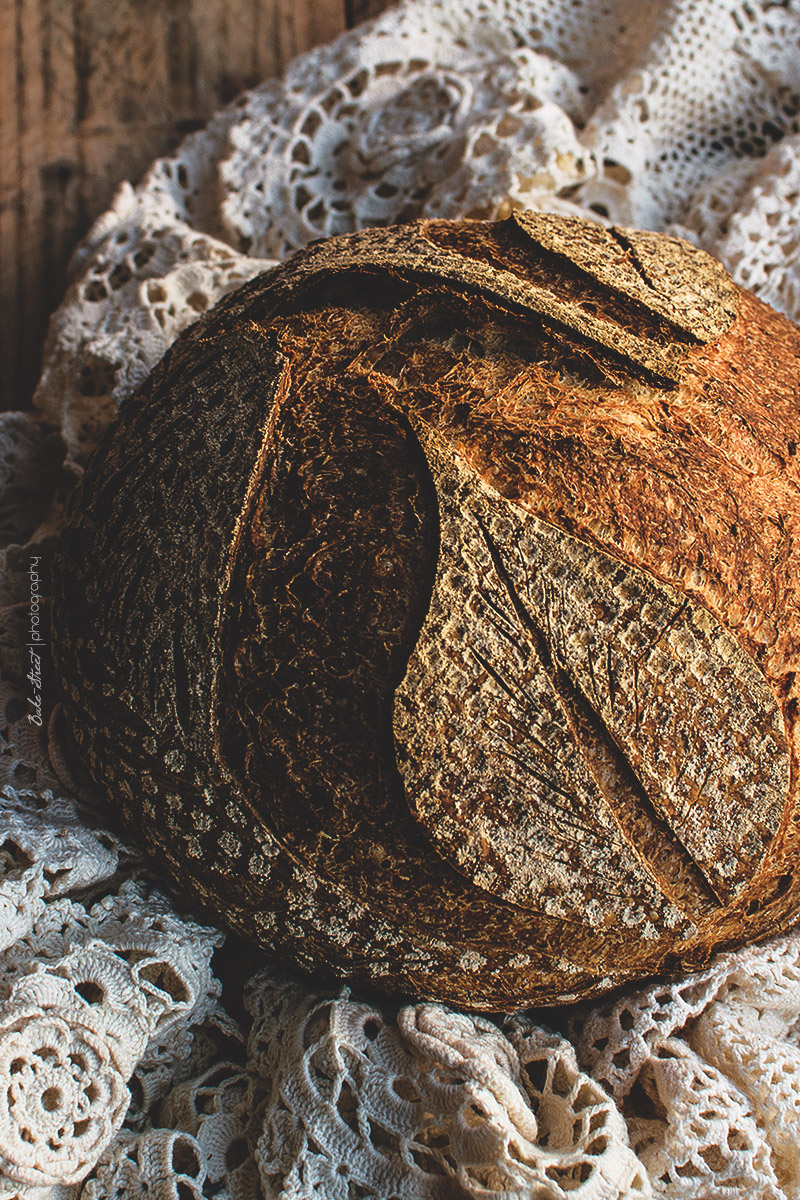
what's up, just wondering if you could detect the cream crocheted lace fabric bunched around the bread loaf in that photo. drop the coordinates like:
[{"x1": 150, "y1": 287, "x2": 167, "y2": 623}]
[{"x1": 6, "y1": 0, "x2": 800, "y2": 1200}]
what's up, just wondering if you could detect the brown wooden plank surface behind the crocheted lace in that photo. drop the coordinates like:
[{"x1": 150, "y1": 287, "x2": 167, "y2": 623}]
[{"x1": 0, "y1": 0, "x2": 389, "y2": 409}]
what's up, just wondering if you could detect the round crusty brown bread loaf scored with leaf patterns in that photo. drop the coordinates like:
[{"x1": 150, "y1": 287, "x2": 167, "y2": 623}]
[{"x1": 53, "y1": 214, "x2": 800, "y2": 1009}]
